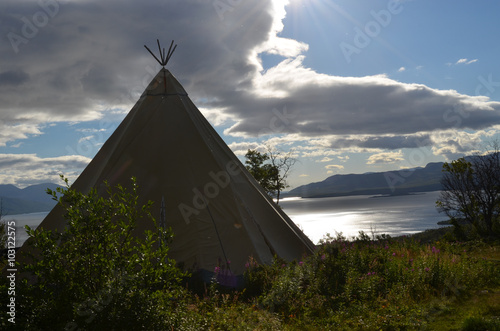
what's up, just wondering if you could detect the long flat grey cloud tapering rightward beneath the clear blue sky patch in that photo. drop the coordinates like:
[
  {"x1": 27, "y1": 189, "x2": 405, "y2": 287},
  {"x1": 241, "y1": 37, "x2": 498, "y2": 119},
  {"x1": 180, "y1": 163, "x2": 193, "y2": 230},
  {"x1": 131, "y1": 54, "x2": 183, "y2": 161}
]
[{"x1": 223, "y1": 67, "x2": 500, "y2": 137}]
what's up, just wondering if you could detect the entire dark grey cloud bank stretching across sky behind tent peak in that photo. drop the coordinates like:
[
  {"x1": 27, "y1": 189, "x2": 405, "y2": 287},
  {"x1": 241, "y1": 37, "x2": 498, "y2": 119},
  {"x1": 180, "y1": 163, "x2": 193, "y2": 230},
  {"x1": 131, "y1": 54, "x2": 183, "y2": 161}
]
[{"x1": 0, "y1": 0, "x2": 500, "y2": 157}]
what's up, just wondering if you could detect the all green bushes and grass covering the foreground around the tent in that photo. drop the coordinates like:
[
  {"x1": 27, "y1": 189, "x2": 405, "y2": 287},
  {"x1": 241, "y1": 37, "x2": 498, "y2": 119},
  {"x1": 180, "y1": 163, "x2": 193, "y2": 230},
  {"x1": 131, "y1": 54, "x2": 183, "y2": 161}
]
[{"x1": 0, "y1": 180, "x2": 500, "y2": 330}]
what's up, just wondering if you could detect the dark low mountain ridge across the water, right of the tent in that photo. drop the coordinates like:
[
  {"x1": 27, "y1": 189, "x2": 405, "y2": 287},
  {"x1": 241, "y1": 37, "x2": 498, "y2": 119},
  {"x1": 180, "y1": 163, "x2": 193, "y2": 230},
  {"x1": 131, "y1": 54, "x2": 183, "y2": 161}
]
[{"x1": 284, "y1": 162, "x2": 443, "y2": 198}]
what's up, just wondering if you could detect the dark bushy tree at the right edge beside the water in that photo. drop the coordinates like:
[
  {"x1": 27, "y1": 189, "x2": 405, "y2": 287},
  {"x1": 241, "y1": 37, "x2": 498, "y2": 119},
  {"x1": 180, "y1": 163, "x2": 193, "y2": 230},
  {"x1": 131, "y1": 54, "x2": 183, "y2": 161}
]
[{"x1": 436, "y1": 148, "x2": 500, "y2": 236}]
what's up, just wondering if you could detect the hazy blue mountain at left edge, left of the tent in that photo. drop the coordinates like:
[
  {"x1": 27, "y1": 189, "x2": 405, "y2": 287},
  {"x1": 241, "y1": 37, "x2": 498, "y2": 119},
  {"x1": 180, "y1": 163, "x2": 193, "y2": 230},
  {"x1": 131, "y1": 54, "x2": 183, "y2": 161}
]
[{"x1": 0, "y1": 183, "x2": 59, "y2": 215}]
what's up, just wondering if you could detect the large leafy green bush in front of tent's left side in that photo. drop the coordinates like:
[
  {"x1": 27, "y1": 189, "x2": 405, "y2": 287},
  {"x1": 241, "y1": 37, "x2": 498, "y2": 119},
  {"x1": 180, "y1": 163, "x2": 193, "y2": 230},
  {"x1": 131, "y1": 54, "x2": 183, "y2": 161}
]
[{"x1": 17, "y1": 179, "x2": 185, "y2": 330}]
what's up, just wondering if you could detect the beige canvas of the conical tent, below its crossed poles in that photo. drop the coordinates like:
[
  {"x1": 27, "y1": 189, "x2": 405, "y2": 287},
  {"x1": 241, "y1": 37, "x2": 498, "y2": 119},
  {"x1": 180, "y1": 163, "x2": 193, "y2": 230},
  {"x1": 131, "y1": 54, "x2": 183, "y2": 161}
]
[{"x1": 28, "y1": 68, "x2": 314, "y2": 275}]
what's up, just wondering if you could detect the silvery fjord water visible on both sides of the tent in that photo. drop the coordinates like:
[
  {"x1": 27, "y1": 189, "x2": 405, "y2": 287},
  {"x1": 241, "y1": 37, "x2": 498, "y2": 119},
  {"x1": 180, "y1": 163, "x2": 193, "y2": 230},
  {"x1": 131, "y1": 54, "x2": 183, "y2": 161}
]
[{"x1": 6, "y1": 192, "x2": 446, "y2": 246}]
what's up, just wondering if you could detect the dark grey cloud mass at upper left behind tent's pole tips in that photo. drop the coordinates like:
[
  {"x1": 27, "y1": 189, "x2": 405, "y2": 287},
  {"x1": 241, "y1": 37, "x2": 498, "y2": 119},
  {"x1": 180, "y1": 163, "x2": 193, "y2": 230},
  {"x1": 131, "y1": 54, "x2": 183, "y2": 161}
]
[{"x1": 0, "y1": 0, "x2": 273, "y2": 121}]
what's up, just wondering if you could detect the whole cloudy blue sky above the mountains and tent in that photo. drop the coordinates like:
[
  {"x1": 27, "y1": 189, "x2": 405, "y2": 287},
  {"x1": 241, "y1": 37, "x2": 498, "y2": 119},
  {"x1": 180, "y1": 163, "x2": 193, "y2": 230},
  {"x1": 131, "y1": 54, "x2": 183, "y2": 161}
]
[{"x1": 0, "y1": 0, "x2": 500, "y2": 188}]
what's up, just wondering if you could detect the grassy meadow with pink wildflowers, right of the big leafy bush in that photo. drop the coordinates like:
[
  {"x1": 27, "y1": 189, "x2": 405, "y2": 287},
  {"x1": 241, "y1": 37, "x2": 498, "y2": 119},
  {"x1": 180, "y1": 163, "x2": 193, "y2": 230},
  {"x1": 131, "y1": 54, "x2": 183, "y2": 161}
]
[{"x1": 170, "y1": 232, "x2": 500, "y2": 330}]
